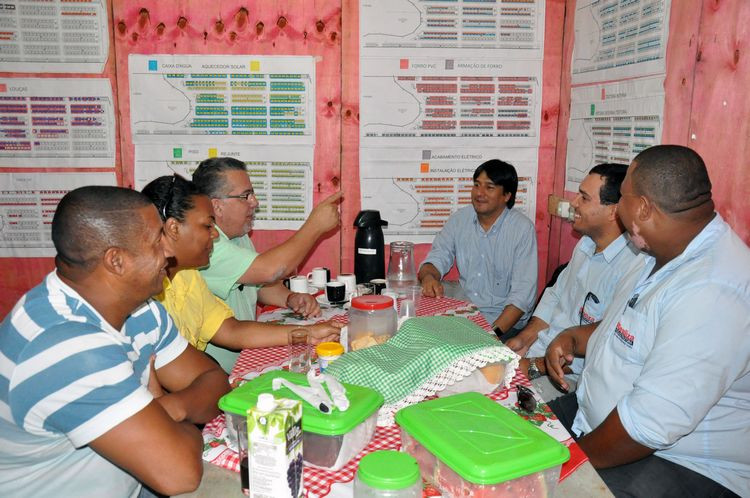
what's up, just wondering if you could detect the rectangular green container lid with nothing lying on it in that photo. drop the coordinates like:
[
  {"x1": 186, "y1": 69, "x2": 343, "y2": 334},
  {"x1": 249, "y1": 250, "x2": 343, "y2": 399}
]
[{"x1": 396, "y1": 392, "x2": 570, "y2": 484}]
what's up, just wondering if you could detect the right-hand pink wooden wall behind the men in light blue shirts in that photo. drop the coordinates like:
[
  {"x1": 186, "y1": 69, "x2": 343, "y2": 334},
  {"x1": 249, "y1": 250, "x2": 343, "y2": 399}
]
[{"x1": 547, "y1": 0, "x2": 750, "y2": 271}]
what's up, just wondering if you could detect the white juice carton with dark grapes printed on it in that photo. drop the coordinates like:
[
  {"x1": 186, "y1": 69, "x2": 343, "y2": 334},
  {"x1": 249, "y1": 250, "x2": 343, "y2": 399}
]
[{"x1": 247, "y1": 393, "x2": 302, "y2": 498}]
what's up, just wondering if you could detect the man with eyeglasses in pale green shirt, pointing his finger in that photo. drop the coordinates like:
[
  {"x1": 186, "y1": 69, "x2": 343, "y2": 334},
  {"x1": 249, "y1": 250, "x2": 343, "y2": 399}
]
[{"x1": 193, "y1": 157, "x2": 342, "y2": 371}]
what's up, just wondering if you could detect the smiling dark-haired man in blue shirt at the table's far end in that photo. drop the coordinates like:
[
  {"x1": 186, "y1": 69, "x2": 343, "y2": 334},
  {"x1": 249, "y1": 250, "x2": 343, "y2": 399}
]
[{"x1": 419, "y1": 159, "x2": 537, "y2": 339}]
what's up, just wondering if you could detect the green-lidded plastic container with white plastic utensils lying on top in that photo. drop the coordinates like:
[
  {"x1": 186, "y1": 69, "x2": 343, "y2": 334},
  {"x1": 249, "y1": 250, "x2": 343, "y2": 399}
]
[{"x1": 219, "y1": 370, "x2": 383, "y2": 470}]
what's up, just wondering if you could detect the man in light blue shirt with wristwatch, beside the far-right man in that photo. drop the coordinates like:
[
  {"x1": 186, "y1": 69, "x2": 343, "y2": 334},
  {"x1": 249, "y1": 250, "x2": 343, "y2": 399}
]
[{"x1": 506, "y1": 164, "x2": 638, "y2": 399}]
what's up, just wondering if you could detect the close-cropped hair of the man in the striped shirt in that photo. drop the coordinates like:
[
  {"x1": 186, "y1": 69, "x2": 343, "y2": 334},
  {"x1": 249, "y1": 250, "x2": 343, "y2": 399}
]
[{"x1": 52, "y1": 186, "x2": 153, "y2": 271}]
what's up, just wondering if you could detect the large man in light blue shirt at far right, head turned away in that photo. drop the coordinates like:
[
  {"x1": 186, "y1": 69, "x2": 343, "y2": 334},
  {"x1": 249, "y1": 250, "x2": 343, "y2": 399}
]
[{"x1": 545, "y1": 145, "x2": 750, "y2": 497}]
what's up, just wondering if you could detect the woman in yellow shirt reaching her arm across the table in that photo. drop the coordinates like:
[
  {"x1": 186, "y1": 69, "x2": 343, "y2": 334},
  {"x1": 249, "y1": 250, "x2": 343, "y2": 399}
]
[{"x1": 143, "y1": 175, "x2": 341, "y2": 360}]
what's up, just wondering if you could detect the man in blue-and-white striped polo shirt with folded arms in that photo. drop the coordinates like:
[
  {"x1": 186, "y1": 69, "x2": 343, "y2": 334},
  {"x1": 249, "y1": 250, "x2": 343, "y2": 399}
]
[{"x1": 0, "y1": 186, "x2": 229, "y2": 497}]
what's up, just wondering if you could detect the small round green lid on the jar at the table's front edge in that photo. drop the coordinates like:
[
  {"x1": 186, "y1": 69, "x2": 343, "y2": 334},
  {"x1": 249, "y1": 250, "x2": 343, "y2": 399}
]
[{"x1": 357, "y1": 450, "x2": 422, "y2": 489}]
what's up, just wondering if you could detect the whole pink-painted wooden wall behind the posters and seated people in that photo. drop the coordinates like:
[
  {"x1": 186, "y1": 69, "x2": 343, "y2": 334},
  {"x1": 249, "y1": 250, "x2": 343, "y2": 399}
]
[{"x1": 0, "y1": 0, "x2": 750, "y2": 317}]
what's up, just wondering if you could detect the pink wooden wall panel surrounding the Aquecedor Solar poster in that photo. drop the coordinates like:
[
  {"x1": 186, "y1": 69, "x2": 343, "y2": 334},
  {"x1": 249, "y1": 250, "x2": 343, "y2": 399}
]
[{"x1": 114, "y1": 0, "x2": 341, "y2": 273}]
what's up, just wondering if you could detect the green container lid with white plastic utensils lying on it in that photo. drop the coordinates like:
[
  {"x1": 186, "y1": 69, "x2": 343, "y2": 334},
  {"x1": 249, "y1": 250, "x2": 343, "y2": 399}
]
[{"x1": 219, "y1": 370, "x2": 383, "y2": 436}]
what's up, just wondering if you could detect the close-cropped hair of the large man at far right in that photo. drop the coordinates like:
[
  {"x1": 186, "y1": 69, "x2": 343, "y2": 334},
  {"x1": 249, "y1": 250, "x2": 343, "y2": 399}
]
[{"x1": 631, "y1": 145, "x2": 711, "y2": 215}]
